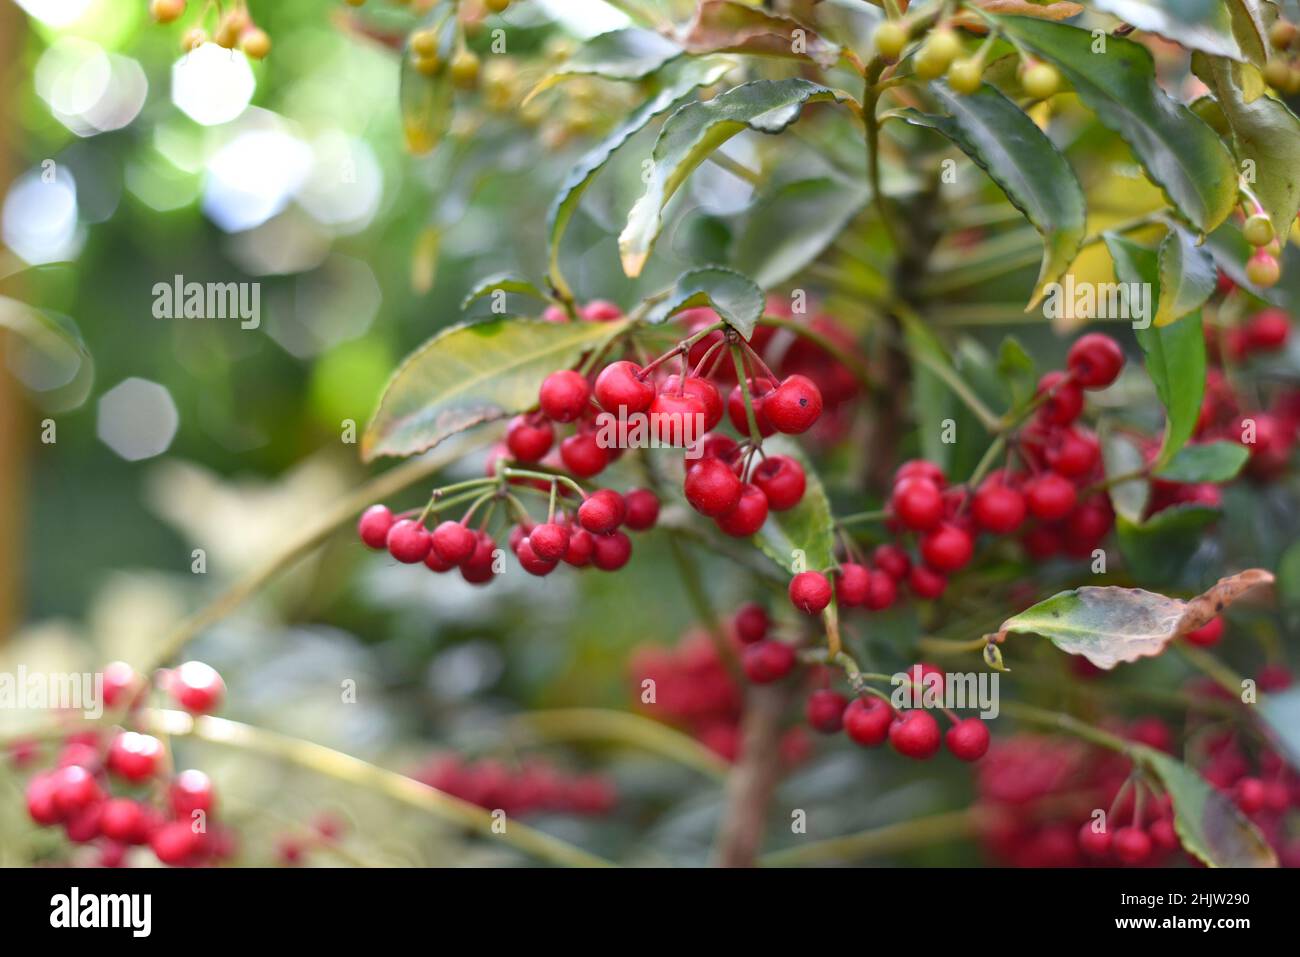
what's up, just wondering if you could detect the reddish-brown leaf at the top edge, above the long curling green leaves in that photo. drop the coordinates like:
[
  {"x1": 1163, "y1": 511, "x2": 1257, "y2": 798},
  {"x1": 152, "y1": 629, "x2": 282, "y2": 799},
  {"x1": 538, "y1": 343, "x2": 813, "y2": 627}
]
[{"x1": 680, "y1": 0, "x2": 840, "y2": 68}]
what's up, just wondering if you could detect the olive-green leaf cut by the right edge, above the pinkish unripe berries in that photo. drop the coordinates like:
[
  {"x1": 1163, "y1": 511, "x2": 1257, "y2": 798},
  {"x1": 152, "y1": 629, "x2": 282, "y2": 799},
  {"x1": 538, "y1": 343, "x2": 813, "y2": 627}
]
[{"x1": 1193, "y1": 57, "x2": 1300, "y2": 237}]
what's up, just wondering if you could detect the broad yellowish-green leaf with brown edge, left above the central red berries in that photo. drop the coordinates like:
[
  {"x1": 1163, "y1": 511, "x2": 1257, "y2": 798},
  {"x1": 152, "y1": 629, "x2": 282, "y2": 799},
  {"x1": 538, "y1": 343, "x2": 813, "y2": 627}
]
[{"x1": 361, "y1": 316, "x2": 627, "y2": 462}]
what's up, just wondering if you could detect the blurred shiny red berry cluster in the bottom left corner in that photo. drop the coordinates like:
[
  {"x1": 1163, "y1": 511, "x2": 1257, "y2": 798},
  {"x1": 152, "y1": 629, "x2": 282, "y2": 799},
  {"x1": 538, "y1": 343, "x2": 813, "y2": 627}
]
[{"x1": 13, "y1": 662, "x2": 234, "y2": 866}]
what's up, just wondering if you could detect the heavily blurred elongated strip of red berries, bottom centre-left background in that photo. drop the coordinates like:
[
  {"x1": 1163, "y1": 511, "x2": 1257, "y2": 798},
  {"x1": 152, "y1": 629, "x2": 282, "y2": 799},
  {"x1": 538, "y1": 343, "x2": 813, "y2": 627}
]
[{"x1": 411, "y1": 754, "x2": 618, "y2": 817}]
